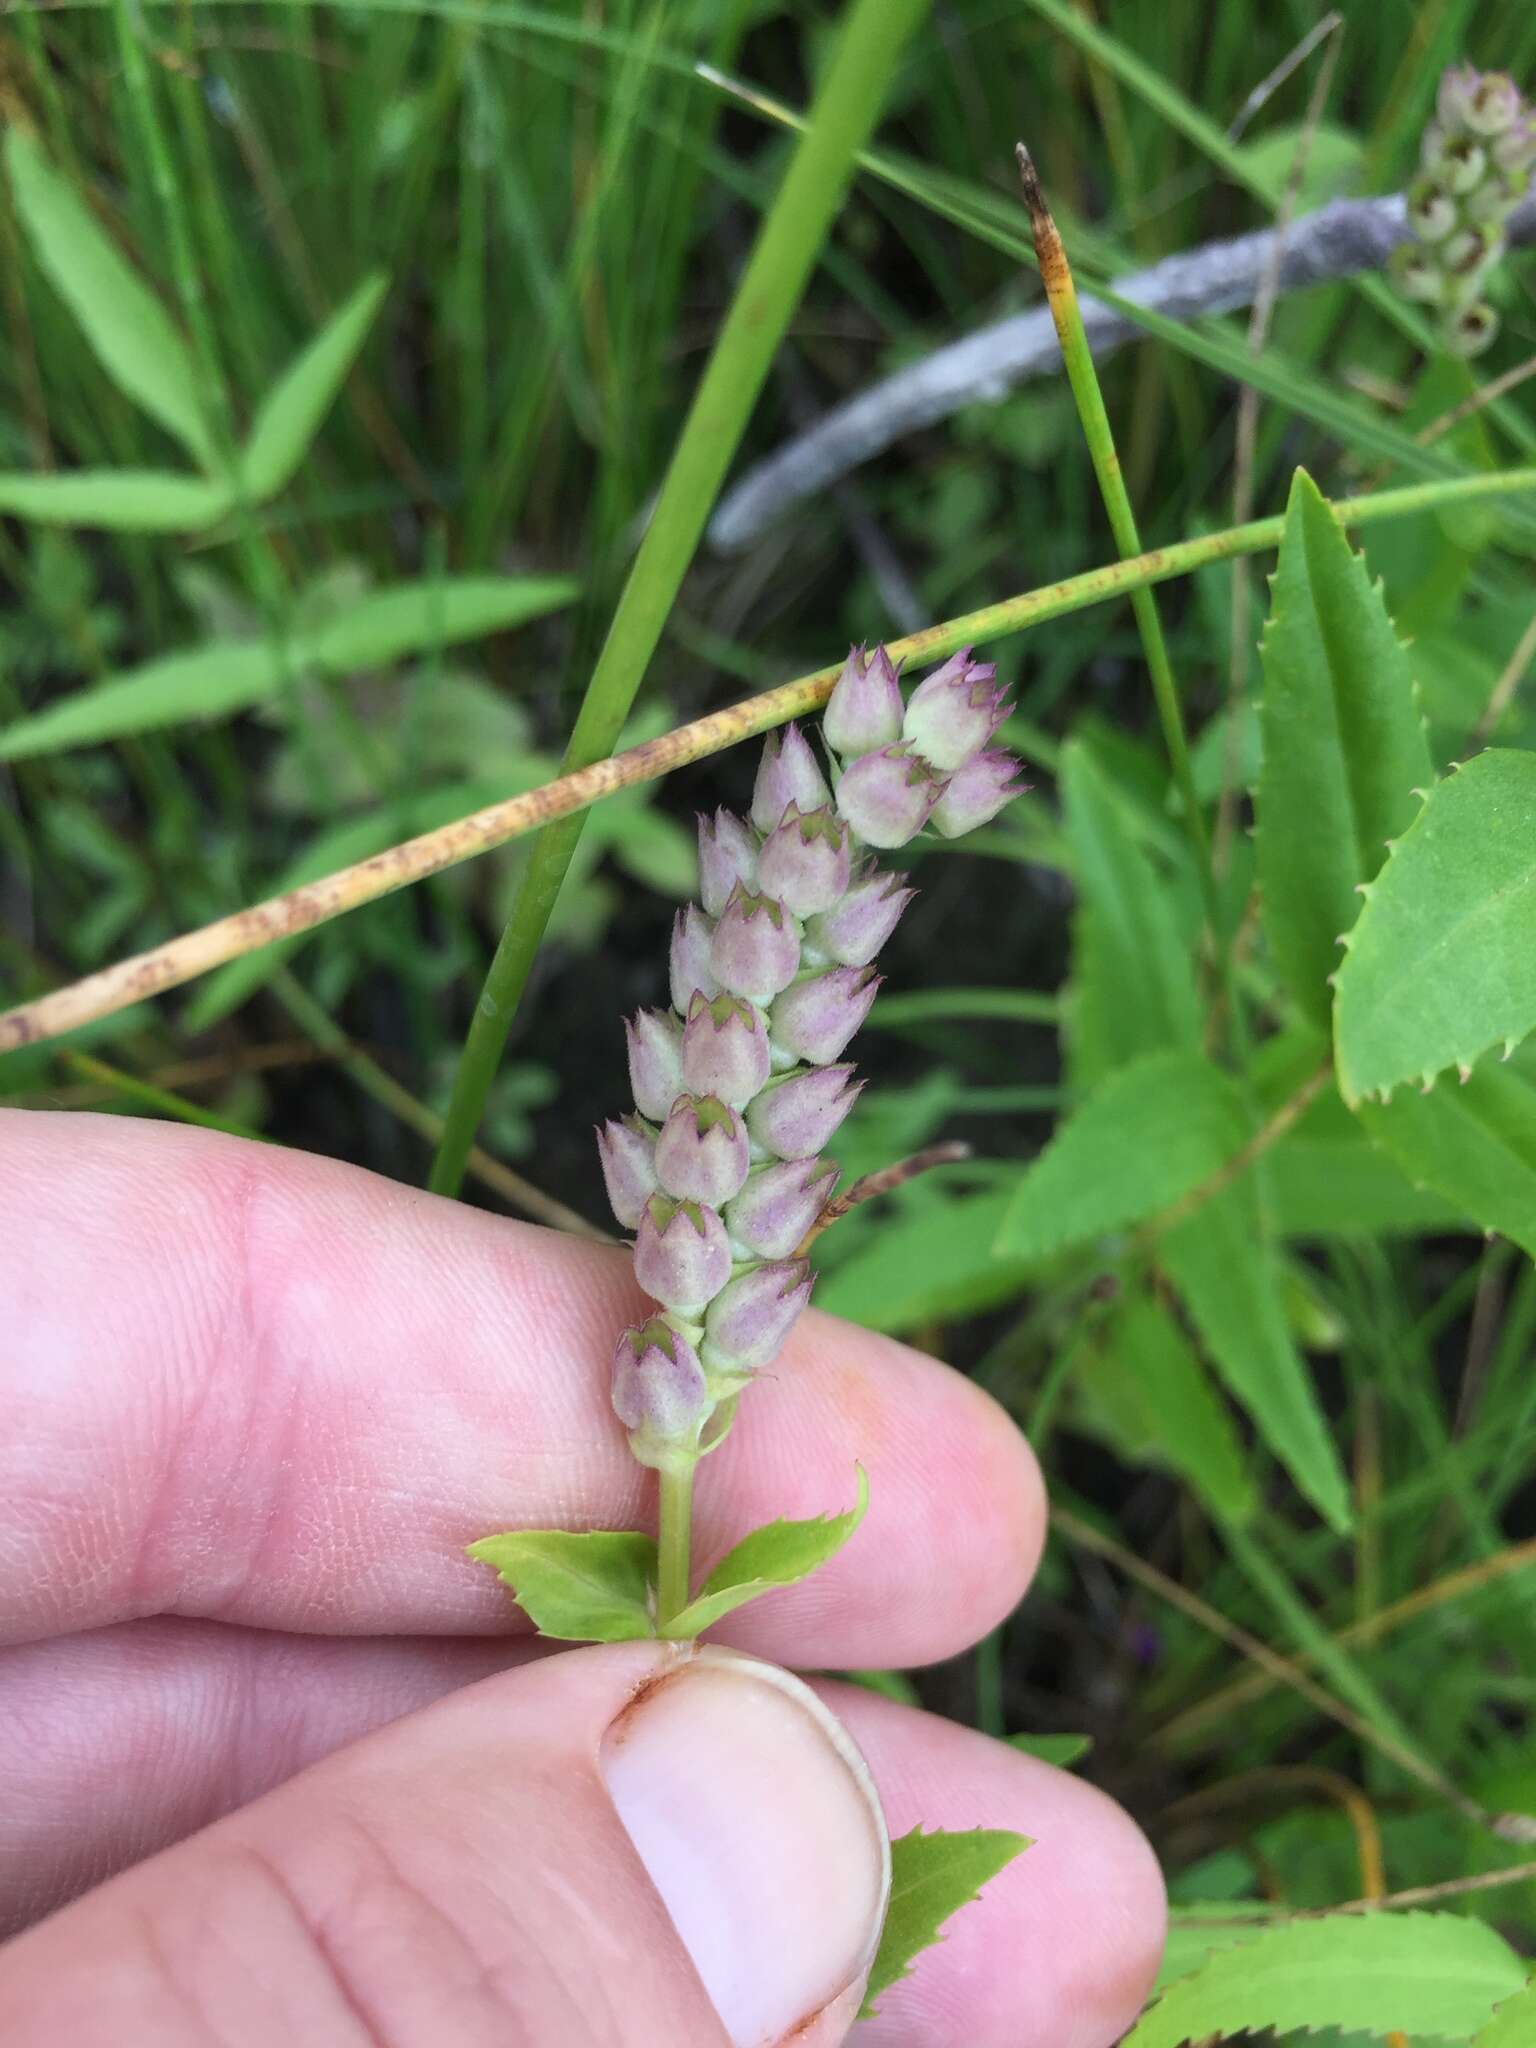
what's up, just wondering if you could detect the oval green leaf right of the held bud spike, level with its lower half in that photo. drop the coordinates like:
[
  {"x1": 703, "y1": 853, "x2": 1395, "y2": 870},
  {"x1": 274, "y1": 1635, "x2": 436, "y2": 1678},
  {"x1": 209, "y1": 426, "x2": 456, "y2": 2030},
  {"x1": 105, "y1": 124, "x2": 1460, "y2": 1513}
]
[{"x1": 997, "y1": 1049, "x2": 1247, "y2": 1257}]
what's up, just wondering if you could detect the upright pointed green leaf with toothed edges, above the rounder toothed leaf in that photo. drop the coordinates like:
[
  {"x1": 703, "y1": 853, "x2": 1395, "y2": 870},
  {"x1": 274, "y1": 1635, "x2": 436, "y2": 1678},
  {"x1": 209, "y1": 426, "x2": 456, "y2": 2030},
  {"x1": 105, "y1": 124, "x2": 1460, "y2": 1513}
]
[{"x1": 1255, "y1": 469, "x2": 1434, "y2": 1024}]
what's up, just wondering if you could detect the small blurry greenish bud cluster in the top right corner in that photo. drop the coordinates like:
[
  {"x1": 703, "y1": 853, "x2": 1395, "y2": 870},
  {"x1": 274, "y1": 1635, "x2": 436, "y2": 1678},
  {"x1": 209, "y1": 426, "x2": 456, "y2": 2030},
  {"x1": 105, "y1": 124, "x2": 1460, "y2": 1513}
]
[{"x1": 1393, "y1": 63, "x2": 1536, "y2": 356}]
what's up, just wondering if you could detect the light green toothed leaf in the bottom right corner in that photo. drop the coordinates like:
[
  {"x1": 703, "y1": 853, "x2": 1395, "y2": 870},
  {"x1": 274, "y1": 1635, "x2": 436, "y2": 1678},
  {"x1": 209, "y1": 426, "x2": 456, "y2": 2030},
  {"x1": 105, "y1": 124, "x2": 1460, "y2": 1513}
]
[{"x1": 1124, "y1": 1913, "x2": 1526, "y2": 2048}]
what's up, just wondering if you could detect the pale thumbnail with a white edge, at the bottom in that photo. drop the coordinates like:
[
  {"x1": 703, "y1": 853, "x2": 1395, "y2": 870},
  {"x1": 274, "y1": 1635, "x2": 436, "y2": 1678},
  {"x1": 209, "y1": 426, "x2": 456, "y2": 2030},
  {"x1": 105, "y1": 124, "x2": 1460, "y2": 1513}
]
[{"x1": 602, "y1": 1647, "x2": 891, "y2": 2048}]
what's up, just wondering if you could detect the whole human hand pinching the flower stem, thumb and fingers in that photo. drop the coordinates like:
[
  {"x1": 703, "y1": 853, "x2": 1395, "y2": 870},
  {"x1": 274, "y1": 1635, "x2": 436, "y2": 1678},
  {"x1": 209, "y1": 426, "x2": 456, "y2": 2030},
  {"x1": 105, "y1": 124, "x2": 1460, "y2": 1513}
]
[{"x1": 0, "y1": 1112, "x2": 1163, "y2": 2048}]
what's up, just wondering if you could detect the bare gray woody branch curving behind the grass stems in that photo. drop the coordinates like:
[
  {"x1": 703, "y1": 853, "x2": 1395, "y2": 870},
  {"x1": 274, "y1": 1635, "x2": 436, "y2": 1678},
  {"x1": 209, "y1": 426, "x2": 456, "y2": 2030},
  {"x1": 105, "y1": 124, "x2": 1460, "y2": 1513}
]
[{"x1": 709, "y1": 193, "x2": 1536, "y2": 555}]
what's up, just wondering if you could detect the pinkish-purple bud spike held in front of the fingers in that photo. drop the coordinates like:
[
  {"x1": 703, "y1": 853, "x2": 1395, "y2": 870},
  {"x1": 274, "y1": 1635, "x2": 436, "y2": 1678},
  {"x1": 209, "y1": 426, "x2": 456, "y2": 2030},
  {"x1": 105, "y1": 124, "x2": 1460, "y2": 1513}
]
[{"x1": 598, "y1": 647, "x2": 1022, "y2": 1468}]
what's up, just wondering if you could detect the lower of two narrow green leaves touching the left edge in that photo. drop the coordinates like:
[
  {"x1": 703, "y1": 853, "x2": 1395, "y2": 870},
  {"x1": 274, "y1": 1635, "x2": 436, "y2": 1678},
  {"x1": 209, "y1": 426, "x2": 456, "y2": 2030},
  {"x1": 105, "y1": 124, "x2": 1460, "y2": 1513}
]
[{"x1": 0, "y1": 641, "x2": 283, "y2": 762}]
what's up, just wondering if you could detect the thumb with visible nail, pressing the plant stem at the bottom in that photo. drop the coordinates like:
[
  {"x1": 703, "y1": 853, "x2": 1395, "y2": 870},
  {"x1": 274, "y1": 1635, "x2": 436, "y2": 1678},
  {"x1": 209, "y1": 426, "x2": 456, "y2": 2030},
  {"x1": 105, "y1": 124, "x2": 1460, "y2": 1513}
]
[{"x1": 0, "y1": 1642, "x2": 889, "y2": 2048}]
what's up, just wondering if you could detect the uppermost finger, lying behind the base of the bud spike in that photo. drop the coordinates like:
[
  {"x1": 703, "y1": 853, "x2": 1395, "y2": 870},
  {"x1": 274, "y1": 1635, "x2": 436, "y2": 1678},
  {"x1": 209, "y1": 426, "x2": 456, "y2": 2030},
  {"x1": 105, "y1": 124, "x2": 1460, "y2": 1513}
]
[{"x1": 0, "y1": 1110, "x2": 1044, "y2": 1667}]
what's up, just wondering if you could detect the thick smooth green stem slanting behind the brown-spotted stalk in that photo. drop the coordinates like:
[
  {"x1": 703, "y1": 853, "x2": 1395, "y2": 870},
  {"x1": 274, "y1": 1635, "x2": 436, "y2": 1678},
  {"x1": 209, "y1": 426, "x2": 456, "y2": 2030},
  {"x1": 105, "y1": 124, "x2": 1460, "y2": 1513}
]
[{"x1": 428, "y1": 0, "x2": 928, "y2": 1194}]
